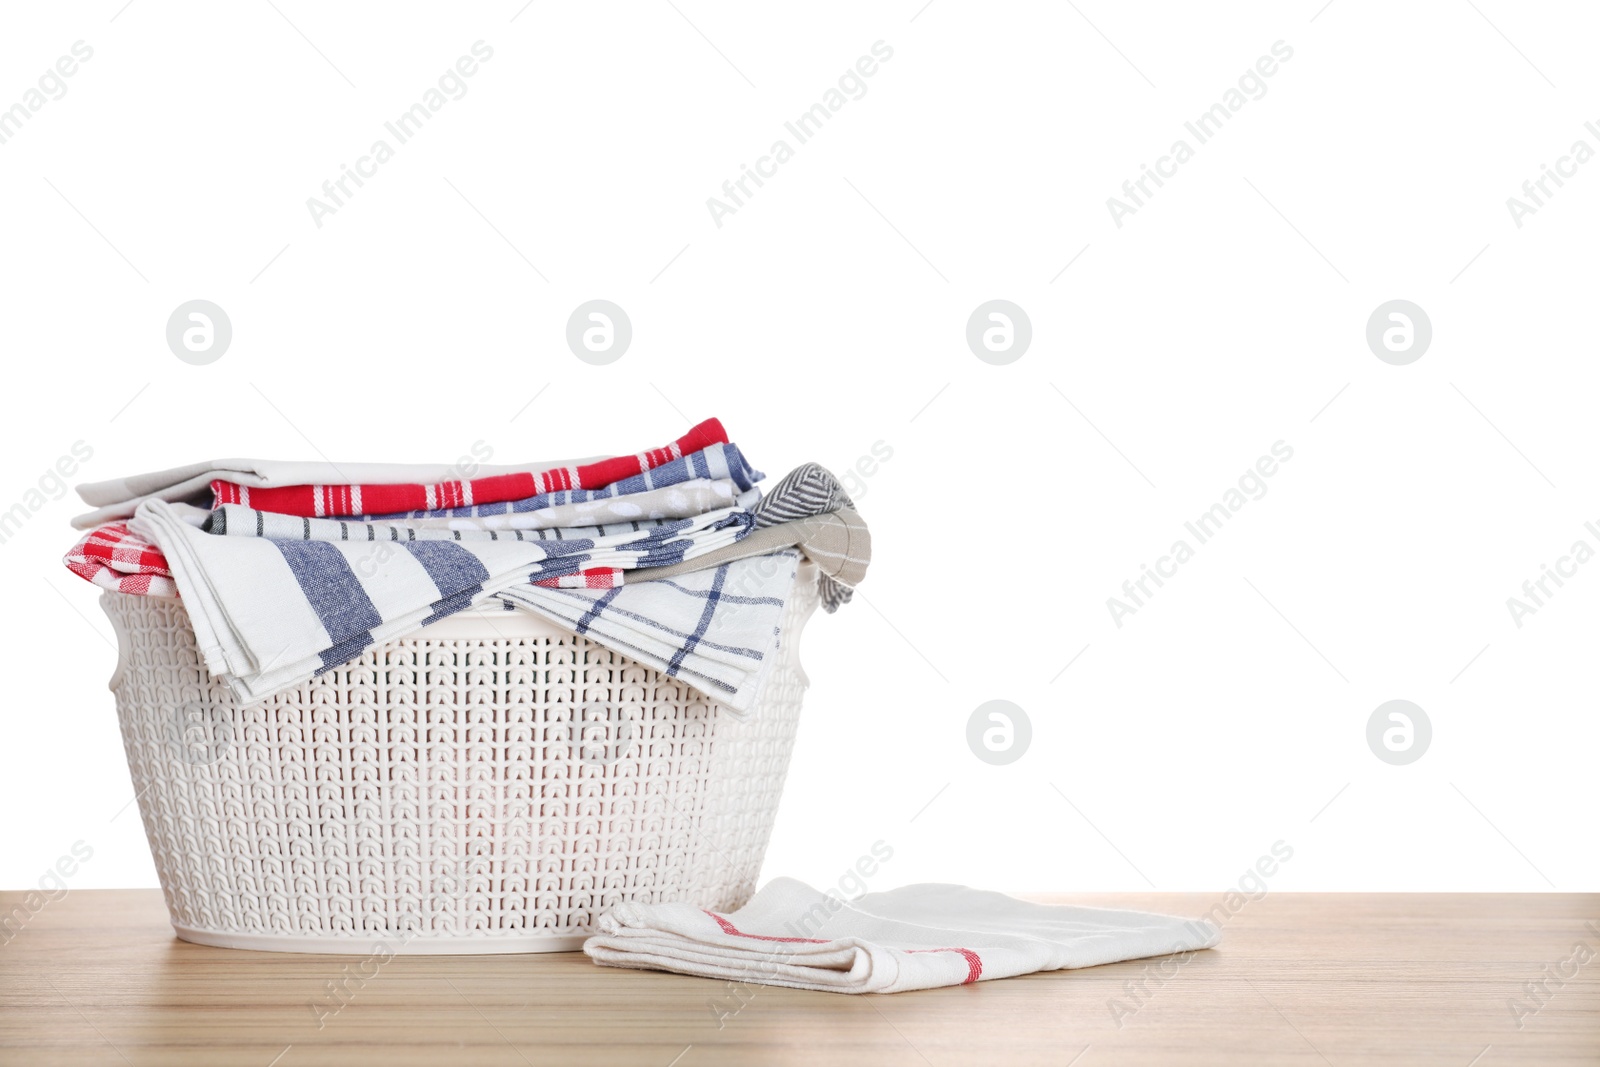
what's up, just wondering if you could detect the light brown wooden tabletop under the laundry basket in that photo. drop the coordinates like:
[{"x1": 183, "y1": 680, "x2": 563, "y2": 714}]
[{"x1": 0, "y1": 889, "x2": 1600, "y2": 1067}]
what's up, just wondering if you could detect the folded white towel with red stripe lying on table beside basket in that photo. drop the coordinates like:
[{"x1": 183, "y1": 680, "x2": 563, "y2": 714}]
[{"x1": 584, "y1": 878, "x2": 1221, "y2": 993}]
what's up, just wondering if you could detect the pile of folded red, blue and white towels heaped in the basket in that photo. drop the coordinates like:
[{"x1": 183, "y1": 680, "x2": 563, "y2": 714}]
[{"x1": 66, "y1": 419, "x2": 870, "y2": 712}]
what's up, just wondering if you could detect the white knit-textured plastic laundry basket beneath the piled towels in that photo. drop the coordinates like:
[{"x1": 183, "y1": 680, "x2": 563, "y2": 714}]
[{"x1": 102, "y1": 560, "x2": 816, "y2": 955}]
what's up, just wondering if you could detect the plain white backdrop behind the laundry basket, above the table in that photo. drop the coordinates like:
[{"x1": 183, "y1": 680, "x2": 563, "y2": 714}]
[{"x1": 0, "y1": 0, "x2": 1600, "y2": 891}]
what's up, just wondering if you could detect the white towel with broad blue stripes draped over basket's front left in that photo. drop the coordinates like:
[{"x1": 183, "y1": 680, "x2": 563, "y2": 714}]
[{"x1": 130, "y1": 501, "x2": 750, "y2": 702}]
